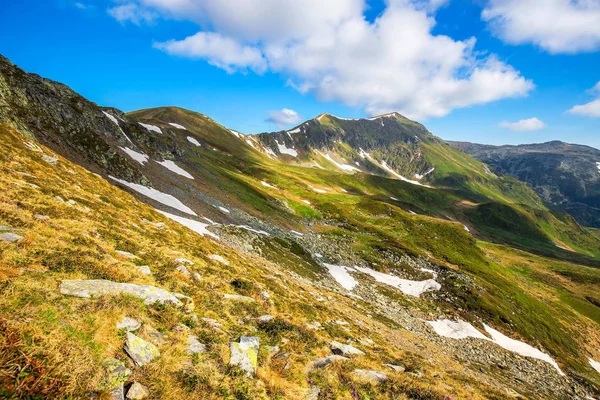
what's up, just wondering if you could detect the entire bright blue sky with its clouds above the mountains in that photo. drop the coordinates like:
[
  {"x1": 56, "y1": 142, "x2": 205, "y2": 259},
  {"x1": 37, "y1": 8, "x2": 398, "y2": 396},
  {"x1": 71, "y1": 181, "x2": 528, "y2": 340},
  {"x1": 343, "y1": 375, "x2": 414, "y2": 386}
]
[{"x1": 0, "y1": 0, "x2": 600, "y2": 148}]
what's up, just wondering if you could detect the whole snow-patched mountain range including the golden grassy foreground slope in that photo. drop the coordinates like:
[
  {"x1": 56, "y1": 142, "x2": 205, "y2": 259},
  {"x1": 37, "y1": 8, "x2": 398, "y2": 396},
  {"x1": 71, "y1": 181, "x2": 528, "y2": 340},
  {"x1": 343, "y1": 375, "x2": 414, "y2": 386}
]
[{"x1": 0, "y1": 54, "x2": 600, "y2": 400}]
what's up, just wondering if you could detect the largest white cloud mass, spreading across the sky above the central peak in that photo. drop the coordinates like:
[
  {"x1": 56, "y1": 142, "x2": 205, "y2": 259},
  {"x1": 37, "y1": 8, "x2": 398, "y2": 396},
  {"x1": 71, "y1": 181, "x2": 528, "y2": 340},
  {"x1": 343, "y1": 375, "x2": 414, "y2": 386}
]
[{"x1": 113, "y1": 0, "x2": 534, "y2": 119}]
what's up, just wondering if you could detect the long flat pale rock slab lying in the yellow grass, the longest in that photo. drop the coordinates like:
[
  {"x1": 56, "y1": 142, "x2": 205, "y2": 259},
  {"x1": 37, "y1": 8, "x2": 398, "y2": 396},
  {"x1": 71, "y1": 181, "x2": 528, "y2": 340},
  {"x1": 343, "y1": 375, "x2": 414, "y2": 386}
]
[{"x1": 60, "y1": 279, "x2": 185, "y2": 306}]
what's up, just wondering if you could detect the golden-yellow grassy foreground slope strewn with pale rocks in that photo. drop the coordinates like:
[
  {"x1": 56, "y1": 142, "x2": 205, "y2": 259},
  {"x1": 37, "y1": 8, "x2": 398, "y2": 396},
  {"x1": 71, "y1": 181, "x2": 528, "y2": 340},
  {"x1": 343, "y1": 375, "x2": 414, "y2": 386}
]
[{"x1": 0, "y1": 125, "x2": 516, "y2": 399}]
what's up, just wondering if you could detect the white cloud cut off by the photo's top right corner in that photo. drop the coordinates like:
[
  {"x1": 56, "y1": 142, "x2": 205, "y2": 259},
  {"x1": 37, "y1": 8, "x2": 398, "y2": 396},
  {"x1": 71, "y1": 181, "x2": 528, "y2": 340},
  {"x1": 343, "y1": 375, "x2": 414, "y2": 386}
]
[{"x1": 481, "y1": 0, "x2": 600, "y2": 54}]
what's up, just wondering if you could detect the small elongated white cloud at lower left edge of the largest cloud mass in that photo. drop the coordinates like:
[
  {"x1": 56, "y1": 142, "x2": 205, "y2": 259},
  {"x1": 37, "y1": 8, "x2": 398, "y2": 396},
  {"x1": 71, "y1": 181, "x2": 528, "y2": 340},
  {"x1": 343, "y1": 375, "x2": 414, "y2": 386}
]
[{"x1": 154, "y1": 32, "x2": 267, "y2": 74}]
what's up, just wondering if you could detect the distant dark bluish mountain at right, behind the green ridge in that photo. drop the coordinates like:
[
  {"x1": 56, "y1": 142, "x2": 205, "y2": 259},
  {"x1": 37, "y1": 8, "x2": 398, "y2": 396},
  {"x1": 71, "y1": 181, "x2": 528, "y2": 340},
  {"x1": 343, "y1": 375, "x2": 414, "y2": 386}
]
[{"x1": 449, "y1": 141, "x2": 600, "y2": 228}]
